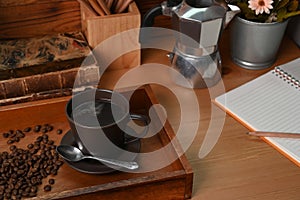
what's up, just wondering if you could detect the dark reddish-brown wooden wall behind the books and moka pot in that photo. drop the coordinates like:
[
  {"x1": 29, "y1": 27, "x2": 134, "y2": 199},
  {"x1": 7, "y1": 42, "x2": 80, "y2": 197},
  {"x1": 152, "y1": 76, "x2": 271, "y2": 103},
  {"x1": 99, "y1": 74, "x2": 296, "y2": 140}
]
[{"x1": 0, "y1": 0, "x2": 171, "y2": 39}]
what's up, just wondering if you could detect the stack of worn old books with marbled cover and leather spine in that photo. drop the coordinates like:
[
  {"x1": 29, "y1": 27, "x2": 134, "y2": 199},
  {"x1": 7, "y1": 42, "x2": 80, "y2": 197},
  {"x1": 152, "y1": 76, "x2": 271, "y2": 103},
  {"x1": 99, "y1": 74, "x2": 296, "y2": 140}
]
[{"x1": 0, "y1": 32, "x2": 100, "y2": 105}]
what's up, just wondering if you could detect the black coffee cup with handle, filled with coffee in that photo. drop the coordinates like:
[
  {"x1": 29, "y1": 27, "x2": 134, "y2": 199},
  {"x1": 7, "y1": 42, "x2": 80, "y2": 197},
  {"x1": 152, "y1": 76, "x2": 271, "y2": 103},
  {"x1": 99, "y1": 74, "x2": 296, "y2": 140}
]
[{"x1": 66, "y1": 89, "x2": 148, "y2": 157}]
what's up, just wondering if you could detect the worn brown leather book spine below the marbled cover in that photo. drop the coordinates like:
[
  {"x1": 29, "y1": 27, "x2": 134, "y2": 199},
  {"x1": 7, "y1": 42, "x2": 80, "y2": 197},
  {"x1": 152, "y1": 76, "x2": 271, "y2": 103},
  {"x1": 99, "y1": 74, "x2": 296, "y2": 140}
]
[{"x1": 0, "y1": 65, "x2": 100, "y2": 106}]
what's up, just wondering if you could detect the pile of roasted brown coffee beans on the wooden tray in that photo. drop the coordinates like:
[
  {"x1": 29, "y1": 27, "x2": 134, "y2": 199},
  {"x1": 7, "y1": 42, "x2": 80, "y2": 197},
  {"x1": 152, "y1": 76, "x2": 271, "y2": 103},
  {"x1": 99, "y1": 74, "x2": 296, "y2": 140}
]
[{"x1": 0, "y1": 124, "x2": 63, "y2": 200}]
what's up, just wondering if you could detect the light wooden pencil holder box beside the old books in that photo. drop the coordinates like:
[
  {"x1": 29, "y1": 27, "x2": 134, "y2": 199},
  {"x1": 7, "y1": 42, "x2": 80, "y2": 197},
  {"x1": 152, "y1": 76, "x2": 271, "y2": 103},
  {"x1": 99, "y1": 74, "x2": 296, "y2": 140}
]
[{"x1": 80, "y1": 2, "x2": 141, "y2": 70}]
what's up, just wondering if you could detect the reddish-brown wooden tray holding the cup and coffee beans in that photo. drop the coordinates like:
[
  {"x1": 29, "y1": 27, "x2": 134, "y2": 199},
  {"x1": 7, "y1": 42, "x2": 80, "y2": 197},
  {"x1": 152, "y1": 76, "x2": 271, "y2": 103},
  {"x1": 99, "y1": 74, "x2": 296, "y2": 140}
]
[{"x1": 0, "y1": 86, "x2": 193, "y2": 200}]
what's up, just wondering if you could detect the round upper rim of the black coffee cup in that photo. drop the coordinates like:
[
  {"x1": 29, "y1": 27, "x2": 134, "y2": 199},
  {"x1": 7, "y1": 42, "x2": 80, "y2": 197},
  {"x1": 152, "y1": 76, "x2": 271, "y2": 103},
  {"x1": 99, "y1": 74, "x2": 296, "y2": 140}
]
[{"x1": 65, "y1": 88, "x2": 128, "y2": 129}]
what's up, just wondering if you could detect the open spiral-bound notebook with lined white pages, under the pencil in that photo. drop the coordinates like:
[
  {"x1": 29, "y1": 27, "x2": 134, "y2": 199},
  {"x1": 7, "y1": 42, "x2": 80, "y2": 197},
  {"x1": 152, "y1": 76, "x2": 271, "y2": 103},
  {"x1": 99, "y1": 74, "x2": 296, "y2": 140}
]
[{"x1": 215, "y1": 58, "x2": 300, "y2": 167}]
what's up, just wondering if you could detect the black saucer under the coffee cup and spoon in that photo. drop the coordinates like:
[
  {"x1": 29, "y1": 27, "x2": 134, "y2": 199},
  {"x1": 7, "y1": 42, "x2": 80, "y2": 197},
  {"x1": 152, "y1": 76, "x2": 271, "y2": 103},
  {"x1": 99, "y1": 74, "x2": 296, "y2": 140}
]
[{"x1": 60, "y1": 130, "x2": 141, "y2": 174}]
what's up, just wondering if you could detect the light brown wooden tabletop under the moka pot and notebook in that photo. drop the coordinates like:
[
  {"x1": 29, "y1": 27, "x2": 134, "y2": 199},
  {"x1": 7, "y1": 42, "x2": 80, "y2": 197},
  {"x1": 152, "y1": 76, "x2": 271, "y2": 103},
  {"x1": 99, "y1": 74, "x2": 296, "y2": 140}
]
[{"x1": 102, "y1": 29, "x2": 300, "y2": 200}]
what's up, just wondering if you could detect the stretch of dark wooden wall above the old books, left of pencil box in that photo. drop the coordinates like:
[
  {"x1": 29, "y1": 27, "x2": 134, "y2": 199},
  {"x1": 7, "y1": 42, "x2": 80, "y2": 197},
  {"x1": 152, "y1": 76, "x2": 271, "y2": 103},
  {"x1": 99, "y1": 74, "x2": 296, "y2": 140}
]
[{"x1": 0, "y1": 0, "x2": 81, "y2": 39}]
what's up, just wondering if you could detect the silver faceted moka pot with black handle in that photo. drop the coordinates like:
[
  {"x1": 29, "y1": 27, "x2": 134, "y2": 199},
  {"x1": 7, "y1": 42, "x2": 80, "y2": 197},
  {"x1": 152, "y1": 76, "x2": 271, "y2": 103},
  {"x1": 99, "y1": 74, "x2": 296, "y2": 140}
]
[{"x1": 142, "y1": 0, "x2": 240, "y2": 88}]
